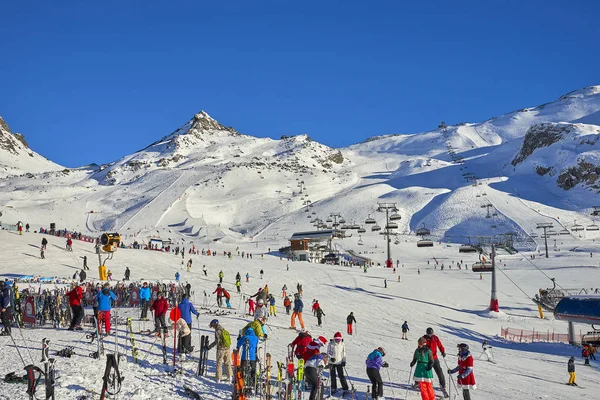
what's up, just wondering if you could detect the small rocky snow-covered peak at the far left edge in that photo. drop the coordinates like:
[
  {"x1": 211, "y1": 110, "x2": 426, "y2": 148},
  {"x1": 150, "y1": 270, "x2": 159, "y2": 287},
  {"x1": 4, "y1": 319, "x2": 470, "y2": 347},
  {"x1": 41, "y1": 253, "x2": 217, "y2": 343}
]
[{"x1": 0, "y1": 117, "x2": 64, "y2": 178}]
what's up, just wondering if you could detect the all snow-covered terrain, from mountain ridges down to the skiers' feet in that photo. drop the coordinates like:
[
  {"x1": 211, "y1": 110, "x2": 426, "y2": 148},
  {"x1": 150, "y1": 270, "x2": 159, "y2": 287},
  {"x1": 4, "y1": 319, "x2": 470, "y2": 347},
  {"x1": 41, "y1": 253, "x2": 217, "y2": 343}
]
[{"x1": 0, "y1": 86, "x2": 600, "y2": 400}]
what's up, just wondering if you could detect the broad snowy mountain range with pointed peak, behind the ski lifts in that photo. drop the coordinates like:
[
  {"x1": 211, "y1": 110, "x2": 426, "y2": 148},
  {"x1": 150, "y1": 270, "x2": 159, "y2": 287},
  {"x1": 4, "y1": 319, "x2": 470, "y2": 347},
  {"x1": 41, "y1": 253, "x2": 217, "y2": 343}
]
[{"x1": 0, "y1": 86, "x2": 600, "y2": 246}]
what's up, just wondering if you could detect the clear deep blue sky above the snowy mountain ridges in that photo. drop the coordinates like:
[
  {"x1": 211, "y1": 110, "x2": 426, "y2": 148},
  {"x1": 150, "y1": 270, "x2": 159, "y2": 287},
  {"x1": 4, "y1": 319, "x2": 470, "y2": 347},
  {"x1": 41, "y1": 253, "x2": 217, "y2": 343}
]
[{"x1": 0, "y1": 0, "x2": 600, "y2": 167}]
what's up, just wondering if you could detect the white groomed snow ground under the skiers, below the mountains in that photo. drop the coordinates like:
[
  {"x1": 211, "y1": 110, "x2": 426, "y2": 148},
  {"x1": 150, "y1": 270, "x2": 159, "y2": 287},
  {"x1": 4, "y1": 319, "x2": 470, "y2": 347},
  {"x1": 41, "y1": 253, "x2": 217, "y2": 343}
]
[{"x1": 0, "y1": 231, "x2": 600, "y2": 400}]
